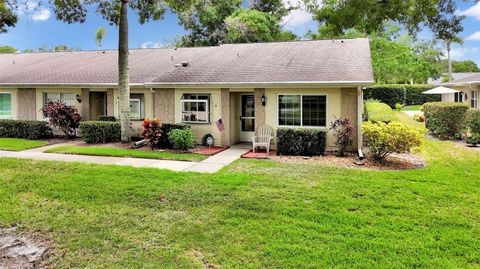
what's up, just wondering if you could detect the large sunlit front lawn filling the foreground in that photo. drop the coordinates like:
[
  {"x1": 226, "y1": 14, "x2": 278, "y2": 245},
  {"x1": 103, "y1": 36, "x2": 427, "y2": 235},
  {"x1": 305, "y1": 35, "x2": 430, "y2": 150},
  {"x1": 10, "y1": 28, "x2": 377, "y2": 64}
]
[{"x1": 0, "y1": 112, "x2": 480, "y2": 268}]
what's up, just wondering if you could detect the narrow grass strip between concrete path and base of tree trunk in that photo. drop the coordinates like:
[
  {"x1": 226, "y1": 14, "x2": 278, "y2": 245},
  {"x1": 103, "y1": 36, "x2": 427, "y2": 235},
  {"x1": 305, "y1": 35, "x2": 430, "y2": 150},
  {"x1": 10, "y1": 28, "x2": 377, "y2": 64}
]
[{"x1": 46, "y1": 146, "x2": 207, "y2": 161}]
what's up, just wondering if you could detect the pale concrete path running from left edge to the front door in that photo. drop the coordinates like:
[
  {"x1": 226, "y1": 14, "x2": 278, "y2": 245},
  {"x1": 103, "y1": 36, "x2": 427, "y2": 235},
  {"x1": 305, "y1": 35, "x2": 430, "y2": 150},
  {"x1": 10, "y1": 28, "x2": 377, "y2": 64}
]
[{"x1": 0, "y1": 144, "x2": 247, "y2": 173}]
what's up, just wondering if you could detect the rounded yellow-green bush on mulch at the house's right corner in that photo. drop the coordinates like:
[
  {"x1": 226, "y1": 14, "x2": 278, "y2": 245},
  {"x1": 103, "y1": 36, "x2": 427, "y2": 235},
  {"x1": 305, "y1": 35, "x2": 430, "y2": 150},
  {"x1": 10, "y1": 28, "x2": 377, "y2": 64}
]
[{"x1": 362, "y1": 122, "x2": 423, "y2": 161}]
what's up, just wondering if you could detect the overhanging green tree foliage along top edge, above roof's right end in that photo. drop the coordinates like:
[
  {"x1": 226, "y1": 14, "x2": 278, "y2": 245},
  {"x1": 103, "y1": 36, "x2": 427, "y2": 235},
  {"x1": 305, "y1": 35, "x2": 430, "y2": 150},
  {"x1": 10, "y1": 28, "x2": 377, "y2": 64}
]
[{"x1": 305, "y1": 0, "x2": 464, "y2": 36}]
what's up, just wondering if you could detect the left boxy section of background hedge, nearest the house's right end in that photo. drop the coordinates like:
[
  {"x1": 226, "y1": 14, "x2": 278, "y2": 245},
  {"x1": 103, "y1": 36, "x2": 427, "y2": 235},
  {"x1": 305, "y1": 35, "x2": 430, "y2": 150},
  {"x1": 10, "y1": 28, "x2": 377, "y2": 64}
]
[{"x1": 363, "y1": 85, "x2": 405, "y2": 108}]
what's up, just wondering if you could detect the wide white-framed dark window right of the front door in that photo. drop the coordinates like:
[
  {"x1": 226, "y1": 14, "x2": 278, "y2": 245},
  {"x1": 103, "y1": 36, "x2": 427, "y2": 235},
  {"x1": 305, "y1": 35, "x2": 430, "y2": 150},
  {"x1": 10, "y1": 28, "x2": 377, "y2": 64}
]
[{"x1": 278, "y1": 94, "x2": 327, "y2": 127}]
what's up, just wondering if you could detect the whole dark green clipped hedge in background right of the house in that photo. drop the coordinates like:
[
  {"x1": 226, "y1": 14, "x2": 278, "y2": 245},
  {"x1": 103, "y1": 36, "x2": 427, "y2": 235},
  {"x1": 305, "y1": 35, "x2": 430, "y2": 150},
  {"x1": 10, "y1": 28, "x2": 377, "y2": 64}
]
[{"x1": 363, "y1": 84, "x2": 442, "y2": 108}]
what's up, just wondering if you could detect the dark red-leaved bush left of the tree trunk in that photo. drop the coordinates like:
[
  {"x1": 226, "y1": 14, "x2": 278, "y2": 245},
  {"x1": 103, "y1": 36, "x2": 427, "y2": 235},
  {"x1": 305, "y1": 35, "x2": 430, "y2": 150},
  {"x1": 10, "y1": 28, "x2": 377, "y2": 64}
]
[{"x1": 42, "y1": 101, "x2": 82, "y2": 138}]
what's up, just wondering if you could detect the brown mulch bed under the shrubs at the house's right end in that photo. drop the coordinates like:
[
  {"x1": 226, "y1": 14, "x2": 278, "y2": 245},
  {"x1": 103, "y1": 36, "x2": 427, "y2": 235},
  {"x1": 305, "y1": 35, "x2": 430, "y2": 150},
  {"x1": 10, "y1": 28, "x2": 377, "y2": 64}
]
[{"x1": 271, "y1": 153, "x2": 426, "y2": 170}]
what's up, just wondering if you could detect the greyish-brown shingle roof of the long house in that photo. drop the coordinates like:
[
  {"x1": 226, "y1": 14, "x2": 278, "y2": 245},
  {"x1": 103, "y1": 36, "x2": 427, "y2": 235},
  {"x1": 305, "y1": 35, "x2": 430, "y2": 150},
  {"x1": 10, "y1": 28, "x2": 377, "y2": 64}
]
[{"x1": 0, "y1": 39, "x2": 373, "y2": 85}]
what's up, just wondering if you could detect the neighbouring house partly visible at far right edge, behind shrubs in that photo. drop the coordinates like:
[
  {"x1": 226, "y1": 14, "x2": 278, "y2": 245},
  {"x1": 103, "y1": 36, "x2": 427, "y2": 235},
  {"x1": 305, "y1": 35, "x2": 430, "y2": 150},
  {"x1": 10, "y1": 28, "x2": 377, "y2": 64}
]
[{"x1": 441, "y1": 73, "x2": 480, "y2": 109}]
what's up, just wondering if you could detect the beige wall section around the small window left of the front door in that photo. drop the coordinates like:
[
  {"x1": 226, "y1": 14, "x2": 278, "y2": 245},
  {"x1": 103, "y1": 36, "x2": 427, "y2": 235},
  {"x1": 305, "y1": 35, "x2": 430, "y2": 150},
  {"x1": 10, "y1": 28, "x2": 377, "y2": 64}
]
[{"x1": 175, "y1": 89, "x2": 225, "y2": 146}]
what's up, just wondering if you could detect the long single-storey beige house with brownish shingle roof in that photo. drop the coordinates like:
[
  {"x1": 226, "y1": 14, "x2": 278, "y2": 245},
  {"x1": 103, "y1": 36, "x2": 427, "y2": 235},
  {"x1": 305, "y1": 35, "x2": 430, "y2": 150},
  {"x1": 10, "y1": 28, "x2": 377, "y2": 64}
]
[{"x1": 0, "y1": 39, "x2": 374, "y2": 149}]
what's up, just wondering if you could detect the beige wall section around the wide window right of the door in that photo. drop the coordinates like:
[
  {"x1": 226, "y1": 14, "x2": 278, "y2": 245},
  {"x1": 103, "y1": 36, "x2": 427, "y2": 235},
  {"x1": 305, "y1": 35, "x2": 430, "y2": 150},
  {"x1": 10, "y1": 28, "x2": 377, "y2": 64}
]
[{"x1": 265, "y1": 88, "x2": 350, "y2": 150}]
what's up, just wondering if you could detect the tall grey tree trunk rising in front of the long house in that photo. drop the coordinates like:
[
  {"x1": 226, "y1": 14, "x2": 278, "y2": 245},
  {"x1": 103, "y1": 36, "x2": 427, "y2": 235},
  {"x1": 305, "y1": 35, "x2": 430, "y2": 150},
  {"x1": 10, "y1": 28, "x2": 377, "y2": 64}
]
[{"x1": 118, "y1": 0, "x2": 131, "y2": 143}]
